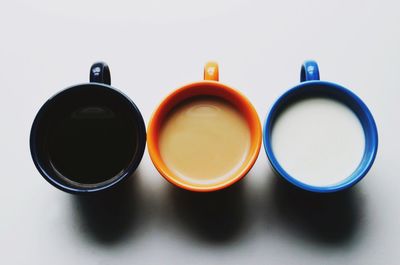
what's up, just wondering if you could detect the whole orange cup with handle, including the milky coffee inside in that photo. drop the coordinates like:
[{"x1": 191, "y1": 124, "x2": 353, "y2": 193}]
[{"x1": 147, "y1": 62, "x2": 262, "y2": 192}]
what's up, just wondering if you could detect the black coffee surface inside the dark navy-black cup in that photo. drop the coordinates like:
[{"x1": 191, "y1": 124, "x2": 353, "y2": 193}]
[{"x1": 48, "y1": 107, "x2": 137, "y2": 184}]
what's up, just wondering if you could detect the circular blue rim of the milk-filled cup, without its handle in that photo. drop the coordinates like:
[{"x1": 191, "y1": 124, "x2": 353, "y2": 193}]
[{"x1": 263, "y1": 80, "x2": 378, "y2": 193}]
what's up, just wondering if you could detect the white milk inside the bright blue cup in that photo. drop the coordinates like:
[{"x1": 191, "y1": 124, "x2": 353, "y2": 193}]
[{"x1": 272, "y1": 98, "x2": 365, "y2": 186}]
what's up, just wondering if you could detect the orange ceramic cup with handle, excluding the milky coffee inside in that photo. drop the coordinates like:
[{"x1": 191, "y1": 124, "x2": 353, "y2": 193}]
[{"x1": 147, "y1": 62, "x2": 262, "y2": 192}]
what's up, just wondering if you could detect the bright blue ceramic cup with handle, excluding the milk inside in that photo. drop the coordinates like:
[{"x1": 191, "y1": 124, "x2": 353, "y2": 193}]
[{"x1": 263, "y1": 61, "x2": 378, "y2": 193}]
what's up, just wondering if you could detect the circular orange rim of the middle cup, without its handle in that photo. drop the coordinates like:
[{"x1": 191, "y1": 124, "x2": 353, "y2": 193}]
[{"x1": 147, "y1": 80, "x2": 262, "y2": 192}]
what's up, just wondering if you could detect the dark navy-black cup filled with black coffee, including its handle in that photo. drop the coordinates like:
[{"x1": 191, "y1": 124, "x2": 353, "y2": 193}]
[{"x1": 30, "y1": 63, "x2": 146, "y2": 193}]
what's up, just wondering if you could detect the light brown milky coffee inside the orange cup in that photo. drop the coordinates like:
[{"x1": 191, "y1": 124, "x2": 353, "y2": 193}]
[{"x1": 159, "y1": 97, "x2": 250, "y2": 184}]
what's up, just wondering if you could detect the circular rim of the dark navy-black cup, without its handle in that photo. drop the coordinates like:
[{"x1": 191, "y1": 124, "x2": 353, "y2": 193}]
[{"x1": 29, "y1": 82, "x2": 147, "y2": 194}]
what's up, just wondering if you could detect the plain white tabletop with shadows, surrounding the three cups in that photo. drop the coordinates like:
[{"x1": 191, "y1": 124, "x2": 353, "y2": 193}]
[{"x1": 0, "y1": 0, "x2": 400, "y2": 264}]
